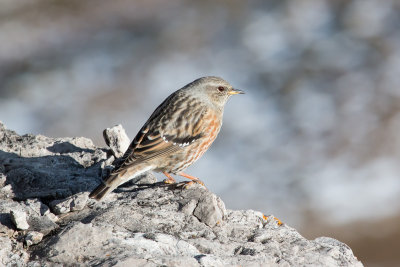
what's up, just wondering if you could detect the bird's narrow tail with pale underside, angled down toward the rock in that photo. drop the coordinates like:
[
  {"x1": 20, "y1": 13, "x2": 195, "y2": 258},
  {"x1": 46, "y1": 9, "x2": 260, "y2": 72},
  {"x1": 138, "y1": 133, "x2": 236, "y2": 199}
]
[{"x1": 89, "y1": 165, "x2": 151, "y2": 200}]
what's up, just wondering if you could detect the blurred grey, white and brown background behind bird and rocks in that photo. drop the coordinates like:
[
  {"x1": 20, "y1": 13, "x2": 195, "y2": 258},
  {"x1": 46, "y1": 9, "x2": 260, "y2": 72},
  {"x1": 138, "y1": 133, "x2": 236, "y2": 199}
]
[{"x1": 0, "y1": 0, "x2": 400, "y2": 266}]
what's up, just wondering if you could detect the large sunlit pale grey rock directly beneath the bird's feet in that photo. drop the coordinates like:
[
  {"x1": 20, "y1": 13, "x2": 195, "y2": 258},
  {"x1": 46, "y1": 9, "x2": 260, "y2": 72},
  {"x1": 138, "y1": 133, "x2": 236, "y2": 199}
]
[{"x1": 34, "y1": 185, "x2": 362, "y2": 266}]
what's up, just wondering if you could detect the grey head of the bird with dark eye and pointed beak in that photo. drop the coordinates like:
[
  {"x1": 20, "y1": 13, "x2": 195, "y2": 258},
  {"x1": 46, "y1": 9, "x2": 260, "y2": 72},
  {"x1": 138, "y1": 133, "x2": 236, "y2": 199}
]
[{"x1": 182, "y1": 76, "x2": 244, "y2": 109}]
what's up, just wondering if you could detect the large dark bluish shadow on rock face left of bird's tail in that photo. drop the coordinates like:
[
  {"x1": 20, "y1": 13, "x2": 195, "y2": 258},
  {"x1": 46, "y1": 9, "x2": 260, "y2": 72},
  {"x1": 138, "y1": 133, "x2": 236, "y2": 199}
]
[{"x1": 0, "y1": 151, "x2": 101, "y2": 200}]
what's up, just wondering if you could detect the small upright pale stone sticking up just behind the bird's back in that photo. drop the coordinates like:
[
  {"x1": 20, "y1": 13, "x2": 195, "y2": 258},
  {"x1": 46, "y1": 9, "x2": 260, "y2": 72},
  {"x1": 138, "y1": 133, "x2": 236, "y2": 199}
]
[{"x1": 103, "y1": 124, "x2": 130, "y2": 158}]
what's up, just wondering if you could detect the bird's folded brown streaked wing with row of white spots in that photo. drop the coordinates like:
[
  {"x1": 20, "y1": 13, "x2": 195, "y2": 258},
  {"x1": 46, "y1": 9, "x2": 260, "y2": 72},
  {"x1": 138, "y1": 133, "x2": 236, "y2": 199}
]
[{"x1": 113, "y1": 94, "x2": 205, "y2": 176}]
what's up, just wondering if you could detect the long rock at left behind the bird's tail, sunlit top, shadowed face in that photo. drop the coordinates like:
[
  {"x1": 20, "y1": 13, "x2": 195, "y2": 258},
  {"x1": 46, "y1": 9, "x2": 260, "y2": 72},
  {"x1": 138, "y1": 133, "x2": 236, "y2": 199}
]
[{"x1": 0, "y1": 122, "x2": 107, "y2": 200}]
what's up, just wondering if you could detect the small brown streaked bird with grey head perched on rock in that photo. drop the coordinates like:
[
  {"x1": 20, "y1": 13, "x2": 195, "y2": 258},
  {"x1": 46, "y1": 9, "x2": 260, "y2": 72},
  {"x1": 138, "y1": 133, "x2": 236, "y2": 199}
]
[{"x1": 89, "y1": 76, "x2": 244, "y2": 200}]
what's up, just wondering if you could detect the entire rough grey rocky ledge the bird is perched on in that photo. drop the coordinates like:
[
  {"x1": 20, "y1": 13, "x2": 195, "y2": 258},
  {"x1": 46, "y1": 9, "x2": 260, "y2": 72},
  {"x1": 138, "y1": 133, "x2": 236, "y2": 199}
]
[{"x1": 0, "y1": 123, "x2": 362, "y2": 266}]
